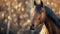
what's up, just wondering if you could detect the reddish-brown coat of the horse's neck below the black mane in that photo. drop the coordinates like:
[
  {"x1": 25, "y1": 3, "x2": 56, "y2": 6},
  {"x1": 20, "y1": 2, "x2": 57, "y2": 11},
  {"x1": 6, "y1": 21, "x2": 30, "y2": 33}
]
[{"x1": 45, "y1": 17, "x2": 59, "y2": 34}]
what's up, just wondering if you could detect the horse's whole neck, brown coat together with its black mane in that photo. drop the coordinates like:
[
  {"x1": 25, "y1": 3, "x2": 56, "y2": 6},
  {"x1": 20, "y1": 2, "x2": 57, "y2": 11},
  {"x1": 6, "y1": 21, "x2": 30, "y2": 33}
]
[{"x1": 44, "y1": 6, "x2": 60, "y2": 34}]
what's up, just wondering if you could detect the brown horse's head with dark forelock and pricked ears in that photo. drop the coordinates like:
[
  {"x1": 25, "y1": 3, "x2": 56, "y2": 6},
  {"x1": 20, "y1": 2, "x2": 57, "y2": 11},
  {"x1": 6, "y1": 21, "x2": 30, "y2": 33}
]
[{"x1": 31, "y1": 1, "x2": 46, "y2": 27}]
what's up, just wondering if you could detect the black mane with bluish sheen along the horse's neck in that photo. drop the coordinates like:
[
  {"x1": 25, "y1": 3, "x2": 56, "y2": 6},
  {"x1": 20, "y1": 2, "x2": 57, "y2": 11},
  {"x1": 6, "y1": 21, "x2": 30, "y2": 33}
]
[{"x1": 45, "y1": 6, "x2": 60, "y2": 28}]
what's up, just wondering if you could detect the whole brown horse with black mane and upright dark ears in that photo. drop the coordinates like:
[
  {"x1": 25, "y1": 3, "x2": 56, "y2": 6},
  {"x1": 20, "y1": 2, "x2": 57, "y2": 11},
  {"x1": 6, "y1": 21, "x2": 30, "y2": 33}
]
[{"x1": 30, "y1": 1, "x2": 60, "y2": 34}]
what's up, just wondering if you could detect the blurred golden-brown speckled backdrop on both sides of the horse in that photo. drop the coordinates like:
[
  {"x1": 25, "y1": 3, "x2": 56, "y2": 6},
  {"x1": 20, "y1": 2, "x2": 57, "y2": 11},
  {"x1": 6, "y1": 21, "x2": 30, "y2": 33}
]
[{"x1": 0, "y1": 0, "x2": 60, "y2": 34}]
